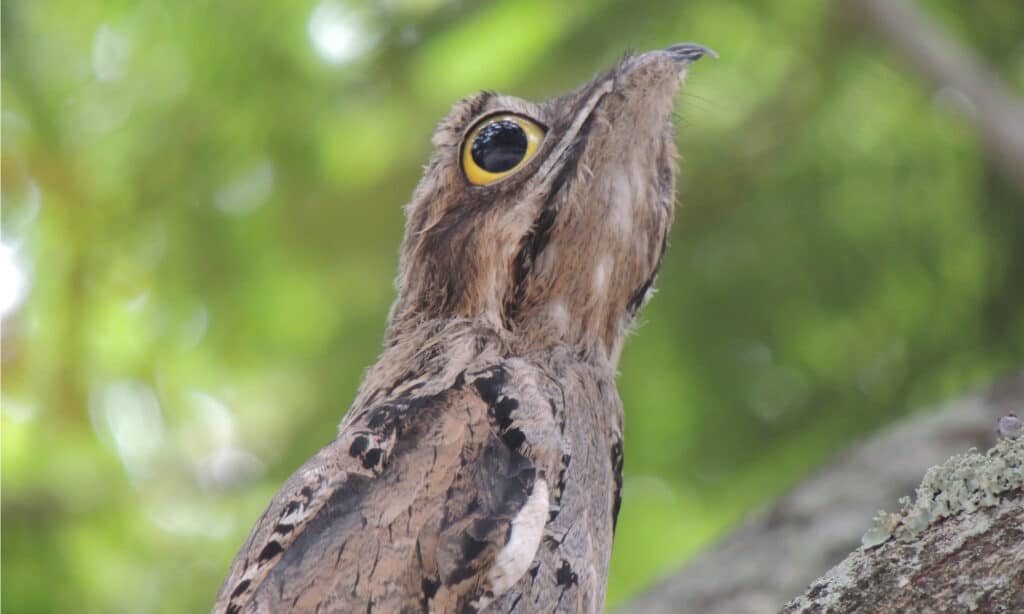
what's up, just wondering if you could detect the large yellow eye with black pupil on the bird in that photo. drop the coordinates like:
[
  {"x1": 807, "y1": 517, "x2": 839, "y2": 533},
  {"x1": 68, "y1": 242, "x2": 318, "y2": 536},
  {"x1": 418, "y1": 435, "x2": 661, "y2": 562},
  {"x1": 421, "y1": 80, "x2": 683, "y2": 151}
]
[{"x1": 462, "y1": 114, "x2": 545, "y2": 185}]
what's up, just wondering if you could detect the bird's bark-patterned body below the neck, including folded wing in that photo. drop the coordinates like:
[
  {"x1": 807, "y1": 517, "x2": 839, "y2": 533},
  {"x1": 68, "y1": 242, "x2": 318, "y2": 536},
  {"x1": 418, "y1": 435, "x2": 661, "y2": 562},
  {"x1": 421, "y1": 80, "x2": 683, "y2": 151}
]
[{"x1": 219, "y1": 336, "x2": 623, "y2": 612}]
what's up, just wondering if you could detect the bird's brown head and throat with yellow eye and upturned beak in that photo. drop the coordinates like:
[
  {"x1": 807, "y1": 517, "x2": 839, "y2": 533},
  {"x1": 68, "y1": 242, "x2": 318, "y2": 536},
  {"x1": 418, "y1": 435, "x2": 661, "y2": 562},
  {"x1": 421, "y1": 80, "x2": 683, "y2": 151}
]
[{"x1": 388, "y1": 44, "x2": 712, "y2": 364}]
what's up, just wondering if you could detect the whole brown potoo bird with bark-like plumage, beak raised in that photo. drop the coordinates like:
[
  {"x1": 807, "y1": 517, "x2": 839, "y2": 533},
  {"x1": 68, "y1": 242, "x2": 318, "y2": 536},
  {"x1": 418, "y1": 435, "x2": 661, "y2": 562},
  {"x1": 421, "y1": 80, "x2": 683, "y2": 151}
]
[{"x1": 214, "y1": 44, "x2": 711, "y2": 613}]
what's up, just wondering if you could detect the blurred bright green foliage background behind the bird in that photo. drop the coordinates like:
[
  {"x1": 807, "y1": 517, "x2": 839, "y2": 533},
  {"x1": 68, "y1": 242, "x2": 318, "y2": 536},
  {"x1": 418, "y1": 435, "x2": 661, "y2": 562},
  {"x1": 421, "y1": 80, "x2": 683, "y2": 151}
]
[{"x1": 2, "y1": 0, "x2": 1024, "y2": 612}]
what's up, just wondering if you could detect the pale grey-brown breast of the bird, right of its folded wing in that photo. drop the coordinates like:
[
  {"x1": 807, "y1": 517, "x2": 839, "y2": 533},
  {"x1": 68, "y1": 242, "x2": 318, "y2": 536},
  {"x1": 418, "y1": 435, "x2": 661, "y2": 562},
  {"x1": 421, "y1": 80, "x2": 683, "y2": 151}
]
[{"x1": 485, "y1": 352, "x2": 623, "y2": 612}]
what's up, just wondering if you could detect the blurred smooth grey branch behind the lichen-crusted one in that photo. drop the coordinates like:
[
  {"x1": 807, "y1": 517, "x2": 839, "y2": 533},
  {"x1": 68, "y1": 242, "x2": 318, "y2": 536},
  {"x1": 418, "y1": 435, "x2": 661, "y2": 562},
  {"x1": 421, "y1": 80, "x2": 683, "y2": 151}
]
[{"x1": 622, "y1": 371, "x2": 1024, "y2": 614}]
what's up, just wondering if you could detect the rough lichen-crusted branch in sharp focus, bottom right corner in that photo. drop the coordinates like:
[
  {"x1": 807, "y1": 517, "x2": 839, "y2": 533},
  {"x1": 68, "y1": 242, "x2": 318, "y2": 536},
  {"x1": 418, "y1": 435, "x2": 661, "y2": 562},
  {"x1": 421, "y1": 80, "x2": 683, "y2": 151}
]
[{"x1": 783, "y1": 438, "x2": 1024, "y2": 614}]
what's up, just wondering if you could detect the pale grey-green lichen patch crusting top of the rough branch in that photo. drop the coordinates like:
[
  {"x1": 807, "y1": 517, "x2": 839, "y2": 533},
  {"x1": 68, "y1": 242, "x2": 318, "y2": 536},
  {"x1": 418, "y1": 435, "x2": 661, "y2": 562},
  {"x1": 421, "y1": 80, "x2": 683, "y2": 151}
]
[{"x1": 861, "y1": 437, "x2": 1024, "y2": 547}]
